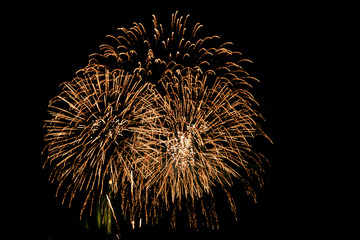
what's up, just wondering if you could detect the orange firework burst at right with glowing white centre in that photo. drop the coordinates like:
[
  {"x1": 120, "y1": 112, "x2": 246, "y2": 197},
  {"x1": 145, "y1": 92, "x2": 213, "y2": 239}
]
[{"x1": 132, "y1": 68, "x2": 263, "y2": 228}]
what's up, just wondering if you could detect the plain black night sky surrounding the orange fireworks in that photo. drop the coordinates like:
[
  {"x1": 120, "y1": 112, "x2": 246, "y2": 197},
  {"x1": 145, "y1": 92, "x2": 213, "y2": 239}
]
[{"x1": 0, "y1": 1, "x2": 359, "y2": 240}]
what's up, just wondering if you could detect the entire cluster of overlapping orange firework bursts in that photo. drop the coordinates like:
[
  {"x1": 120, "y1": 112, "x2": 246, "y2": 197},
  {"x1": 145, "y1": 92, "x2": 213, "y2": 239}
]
[{"x1": 45, "y1": 13, "x2": 266, "y2": 232}]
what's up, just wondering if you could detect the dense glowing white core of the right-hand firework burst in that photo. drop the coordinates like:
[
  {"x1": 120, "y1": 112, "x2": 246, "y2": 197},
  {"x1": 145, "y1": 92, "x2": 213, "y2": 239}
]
[{"x1": 167, "y1": 132, "x2": 195, "y2": 170}]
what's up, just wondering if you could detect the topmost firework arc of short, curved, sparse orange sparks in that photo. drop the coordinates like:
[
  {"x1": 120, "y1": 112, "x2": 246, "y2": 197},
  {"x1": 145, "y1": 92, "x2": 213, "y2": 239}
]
[{"x1": 89, "y1": 12, "x2": 255, "y2": 90}]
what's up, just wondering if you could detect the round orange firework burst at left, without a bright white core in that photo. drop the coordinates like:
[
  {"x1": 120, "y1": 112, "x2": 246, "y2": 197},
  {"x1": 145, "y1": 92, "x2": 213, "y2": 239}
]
[{"x1": 45, "y1": 68, "x2": 159, "y2": 217}]
